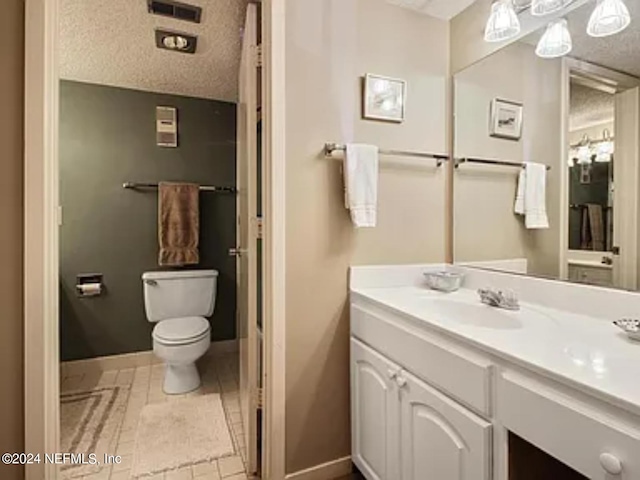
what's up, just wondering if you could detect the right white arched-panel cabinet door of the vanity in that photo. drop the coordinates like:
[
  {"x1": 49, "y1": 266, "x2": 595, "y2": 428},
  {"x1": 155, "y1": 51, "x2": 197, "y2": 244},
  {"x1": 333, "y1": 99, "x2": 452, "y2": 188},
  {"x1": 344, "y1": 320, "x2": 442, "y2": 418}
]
[{"x1": 398, "y1": 371, "x2": 491, "y2": 480}]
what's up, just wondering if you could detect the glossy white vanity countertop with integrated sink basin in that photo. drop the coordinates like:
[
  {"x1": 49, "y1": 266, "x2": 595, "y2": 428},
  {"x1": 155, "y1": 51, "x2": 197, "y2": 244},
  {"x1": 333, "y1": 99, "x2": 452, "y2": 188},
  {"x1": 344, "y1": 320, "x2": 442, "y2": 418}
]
[{"x1": 351, "y1": 286, "x2": 640, "y2": 415}]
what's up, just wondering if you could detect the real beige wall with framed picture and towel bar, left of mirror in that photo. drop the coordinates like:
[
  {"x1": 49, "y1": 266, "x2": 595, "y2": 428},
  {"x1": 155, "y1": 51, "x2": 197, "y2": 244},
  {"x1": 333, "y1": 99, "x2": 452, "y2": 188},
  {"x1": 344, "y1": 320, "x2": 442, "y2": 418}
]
[{"x1": 286, "y1": 0, "x2": 449, "y2": 473}]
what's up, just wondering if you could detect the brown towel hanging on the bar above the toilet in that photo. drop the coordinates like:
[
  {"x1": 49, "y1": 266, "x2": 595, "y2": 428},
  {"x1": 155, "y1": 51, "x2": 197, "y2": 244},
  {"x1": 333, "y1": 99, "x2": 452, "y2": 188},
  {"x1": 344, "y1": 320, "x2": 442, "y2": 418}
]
[{"x1": 158, "y1": 182, "x2": 200, "y2": 267}]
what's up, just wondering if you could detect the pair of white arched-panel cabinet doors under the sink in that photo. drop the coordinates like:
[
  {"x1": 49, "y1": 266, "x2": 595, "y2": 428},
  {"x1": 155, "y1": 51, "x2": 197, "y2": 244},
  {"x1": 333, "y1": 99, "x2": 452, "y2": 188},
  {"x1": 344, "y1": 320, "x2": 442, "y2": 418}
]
[{"x1": 351, "y1": 338, "x2": 491, "y2": 480}]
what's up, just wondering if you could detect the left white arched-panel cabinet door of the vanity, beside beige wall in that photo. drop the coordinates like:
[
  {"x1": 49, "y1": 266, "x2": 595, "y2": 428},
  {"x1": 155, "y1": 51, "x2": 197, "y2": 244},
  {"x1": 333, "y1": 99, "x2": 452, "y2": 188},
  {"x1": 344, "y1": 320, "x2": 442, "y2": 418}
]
[{"x1": 351, "y1": 338, "x2": 400, "y2": 480}]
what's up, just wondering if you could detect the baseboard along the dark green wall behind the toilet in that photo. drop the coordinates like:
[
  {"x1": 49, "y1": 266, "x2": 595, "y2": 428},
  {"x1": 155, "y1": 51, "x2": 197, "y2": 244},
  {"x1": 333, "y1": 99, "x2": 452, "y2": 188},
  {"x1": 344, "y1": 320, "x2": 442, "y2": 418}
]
[{"x1": 60, "y1": 340, "x2": 238, "y2": 378}]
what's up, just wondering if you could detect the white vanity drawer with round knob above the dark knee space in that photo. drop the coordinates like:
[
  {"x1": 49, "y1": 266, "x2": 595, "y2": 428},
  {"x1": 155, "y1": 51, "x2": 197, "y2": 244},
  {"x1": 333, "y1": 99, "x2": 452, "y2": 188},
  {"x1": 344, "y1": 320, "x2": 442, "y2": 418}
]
[{"x1": 496, "y1": 372, "x2": 640, "y2": 480}]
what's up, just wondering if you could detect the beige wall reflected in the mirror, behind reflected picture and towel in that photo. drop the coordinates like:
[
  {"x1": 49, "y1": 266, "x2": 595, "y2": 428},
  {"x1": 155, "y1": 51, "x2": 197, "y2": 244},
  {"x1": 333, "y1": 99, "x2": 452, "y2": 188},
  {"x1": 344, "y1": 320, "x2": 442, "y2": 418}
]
[{"x1": 454, "y1": 43, "x2": 563, "y2": 276}]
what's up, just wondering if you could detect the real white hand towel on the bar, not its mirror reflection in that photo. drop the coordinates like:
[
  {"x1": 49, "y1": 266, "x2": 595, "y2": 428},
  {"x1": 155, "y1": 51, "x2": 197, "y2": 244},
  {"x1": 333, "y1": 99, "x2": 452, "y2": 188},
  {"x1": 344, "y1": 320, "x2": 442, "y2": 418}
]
[{"x1": 344, "y1": 144, "x2": 379, "y2": 228}]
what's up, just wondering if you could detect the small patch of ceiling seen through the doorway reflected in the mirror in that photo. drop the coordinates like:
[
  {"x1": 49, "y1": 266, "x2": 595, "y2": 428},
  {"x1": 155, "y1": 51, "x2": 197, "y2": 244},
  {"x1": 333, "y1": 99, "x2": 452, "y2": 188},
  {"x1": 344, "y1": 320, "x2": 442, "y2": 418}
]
[{"x1": 569, "y1": 82, "x2": 615, "y2": 132}]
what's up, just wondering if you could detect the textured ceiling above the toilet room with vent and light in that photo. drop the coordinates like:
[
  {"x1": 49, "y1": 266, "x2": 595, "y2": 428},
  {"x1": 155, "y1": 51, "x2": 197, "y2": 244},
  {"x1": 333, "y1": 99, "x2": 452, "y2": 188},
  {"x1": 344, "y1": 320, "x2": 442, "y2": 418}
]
[{"x1": 60, "y1": 0, "x2": 247, "y2": 102}]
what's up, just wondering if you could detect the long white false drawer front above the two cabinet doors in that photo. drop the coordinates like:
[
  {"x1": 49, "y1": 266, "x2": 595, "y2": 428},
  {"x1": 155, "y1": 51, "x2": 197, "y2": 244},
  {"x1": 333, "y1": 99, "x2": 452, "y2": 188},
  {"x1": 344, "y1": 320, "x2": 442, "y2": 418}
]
[{"x1": 351, "y1": 305, "x2": 493, "y2": 417}]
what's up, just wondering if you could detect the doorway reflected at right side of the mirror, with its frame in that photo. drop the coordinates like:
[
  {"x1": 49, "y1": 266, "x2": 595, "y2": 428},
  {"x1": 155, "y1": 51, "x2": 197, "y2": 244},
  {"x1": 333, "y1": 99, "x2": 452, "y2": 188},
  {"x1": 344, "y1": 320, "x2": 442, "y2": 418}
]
[{"x1": 560, "y1": 59, "x2": 640, "y2": 289}]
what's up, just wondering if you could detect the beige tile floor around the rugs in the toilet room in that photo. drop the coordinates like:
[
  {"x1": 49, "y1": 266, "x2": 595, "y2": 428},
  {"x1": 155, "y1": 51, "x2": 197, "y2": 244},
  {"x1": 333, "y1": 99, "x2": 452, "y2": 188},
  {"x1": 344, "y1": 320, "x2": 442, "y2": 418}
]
[{"x1": 60, "y1": 354, "x2": 253, "y2": 480}]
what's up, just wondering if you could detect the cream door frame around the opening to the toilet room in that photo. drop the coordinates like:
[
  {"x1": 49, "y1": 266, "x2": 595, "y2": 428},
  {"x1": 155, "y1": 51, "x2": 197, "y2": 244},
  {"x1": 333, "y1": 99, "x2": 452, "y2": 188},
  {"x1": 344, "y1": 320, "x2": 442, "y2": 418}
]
[{"x1": 24, "y1": 0, "x2": 286, "y2": 480}]
